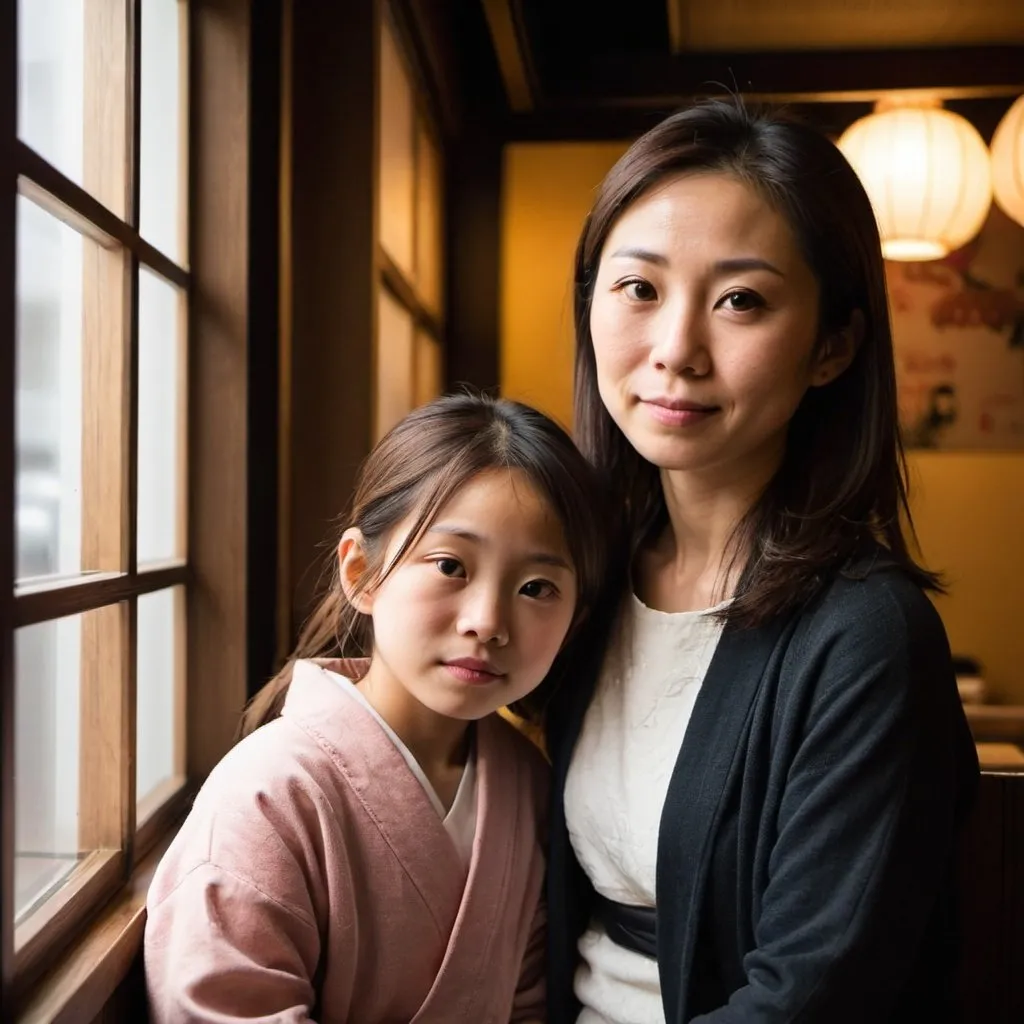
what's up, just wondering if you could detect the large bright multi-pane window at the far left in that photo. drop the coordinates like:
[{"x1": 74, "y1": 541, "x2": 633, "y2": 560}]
[{"x1": 0, "y1": 0, "x2": 191, "y2": 991}]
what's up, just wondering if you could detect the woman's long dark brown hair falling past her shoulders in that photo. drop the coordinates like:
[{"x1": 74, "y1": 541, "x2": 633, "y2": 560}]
[{"x1": 574, "y1": 98, "x2": 941, "y2": 626}]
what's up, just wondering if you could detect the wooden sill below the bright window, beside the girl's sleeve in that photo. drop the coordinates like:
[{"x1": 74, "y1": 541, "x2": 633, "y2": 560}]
[{"x1": 16, "y1": 828, "x2": 177, "y2": 1024}]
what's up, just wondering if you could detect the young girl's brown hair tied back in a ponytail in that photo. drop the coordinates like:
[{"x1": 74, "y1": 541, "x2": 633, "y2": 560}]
[{"x1": 239, "y1": 393, "x2": 608, "y2": 735}]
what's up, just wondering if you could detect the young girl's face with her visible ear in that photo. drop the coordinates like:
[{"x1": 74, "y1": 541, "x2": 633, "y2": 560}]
[{"x1": 340, "y1": 470, "x2": 577, "y2": 720}]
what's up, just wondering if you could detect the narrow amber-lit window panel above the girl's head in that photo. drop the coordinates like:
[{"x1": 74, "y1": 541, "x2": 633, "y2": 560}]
[{"x1": 375, "y1": 17, "x2": 444, "y2": 438}]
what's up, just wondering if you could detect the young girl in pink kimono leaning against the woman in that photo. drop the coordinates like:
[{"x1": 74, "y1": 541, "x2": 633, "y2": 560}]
[{"x1": 145, "y1": 395, "x2": 606, "y2": 1024}]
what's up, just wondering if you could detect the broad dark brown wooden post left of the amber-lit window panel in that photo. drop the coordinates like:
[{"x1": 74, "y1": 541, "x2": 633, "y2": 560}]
[{"x1": 288, "y1": 0, "x2": 381, "y2": 624}]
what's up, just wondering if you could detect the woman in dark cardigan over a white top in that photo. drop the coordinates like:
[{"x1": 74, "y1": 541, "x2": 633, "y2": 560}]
[{"x1": 549, "y1": 101, "x2": 978, "y2": 1024}]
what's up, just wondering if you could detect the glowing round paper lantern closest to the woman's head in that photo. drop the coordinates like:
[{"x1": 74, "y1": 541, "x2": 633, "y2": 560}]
[{"x1": 839, "y1": 98, "x2": 992, "y2": 260}]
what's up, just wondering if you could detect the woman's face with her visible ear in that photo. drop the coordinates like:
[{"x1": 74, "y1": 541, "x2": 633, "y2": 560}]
[{"x1": 590, "y1": 173, "x2": 852, "y2": 482}]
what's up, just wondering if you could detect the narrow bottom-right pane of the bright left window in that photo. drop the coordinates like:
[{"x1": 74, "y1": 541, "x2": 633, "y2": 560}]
[{"x1": 135, "y1": 587, "x2": 184, "y2": 803}]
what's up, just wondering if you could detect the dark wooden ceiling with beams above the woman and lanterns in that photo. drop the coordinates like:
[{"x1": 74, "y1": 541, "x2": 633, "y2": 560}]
[{"x1": 399, "y1": 0, "x2": 1024, "y2": 141}]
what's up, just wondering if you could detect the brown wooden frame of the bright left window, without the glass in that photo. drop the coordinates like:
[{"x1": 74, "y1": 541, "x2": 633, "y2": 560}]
[{"x1": 0, "y1": 0, "x2": 252, "y2": 1021}]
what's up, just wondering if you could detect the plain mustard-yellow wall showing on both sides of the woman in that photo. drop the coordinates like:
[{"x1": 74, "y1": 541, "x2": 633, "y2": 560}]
[{"x1": 501, "y1": 142, "x2": 1024, "y2": 703}]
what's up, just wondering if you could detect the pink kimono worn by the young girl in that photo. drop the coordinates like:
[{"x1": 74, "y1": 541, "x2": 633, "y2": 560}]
[{"x1": 145, "y1": 662, "x2": 548, "y2": 1024}]
